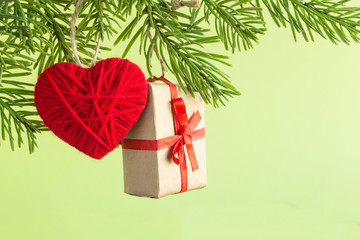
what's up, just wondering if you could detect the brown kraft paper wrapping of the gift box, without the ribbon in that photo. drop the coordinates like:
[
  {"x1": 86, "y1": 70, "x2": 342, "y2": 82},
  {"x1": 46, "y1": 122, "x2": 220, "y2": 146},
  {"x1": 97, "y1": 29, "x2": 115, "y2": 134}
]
[{"x1": 123, "y1": 83, "x2": 206, "y2": 198}]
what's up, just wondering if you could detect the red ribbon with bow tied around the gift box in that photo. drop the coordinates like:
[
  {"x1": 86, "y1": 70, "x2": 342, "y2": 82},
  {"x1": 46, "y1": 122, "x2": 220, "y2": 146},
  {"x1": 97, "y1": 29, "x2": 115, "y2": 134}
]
[{"x1": 121, "y1": 77, "x2": 205, "y2": 192}]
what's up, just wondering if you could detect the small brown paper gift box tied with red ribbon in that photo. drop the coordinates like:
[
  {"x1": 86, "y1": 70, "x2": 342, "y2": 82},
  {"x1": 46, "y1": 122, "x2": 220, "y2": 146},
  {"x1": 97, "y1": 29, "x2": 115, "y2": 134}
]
[{"x1": 122, "y1": 78, "x2": 206, "y2": 198}]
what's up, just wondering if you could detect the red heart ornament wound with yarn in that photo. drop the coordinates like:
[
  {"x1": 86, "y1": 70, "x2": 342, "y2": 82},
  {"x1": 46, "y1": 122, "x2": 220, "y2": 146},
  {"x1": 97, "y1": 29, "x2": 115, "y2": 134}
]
[{"x1": 35, "y1": 58, "x2": 147, "y2": 159}]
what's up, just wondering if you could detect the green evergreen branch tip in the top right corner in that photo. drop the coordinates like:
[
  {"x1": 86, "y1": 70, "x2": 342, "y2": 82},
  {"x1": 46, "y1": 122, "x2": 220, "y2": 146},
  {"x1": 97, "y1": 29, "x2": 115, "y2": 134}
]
[{"x1": 262, "y1": 0, "x2": 360, "y2": 44}]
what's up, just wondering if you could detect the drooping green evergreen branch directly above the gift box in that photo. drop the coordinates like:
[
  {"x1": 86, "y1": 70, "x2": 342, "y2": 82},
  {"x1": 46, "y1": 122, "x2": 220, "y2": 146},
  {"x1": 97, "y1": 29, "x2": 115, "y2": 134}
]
[{"x1": 115, "y1": 1, "x2": 240, "y2": 106}]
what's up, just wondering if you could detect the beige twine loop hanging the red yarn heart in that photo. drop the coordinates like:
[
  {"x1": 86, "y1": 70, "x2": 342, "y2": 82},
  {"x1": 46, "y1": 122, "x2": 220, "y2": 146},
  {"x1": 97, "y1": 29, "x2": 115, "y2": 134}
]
[{"x1": 70, "y1": 0, "x2": 101, "y2": 67}]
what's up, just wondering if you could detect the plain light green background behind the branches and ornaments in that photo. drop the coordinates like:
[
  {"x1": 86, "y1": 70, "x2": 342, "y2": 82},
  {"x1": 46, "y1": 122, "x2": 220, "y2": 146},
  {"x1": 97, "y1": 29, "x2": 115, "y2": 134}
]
[{"x1": 0, "y1": 19, "x2": 360, "y2": 240}]
